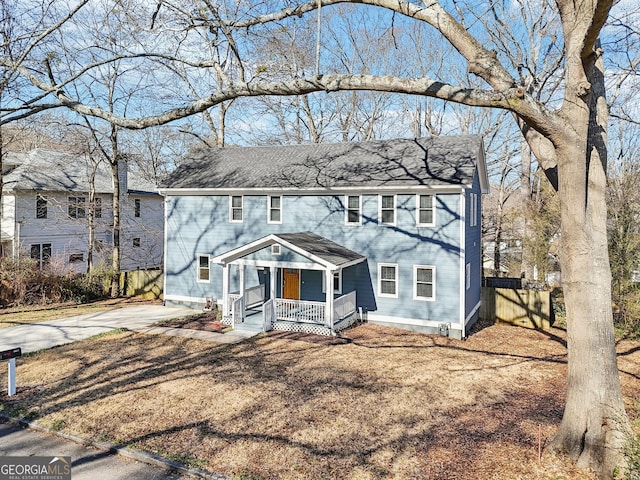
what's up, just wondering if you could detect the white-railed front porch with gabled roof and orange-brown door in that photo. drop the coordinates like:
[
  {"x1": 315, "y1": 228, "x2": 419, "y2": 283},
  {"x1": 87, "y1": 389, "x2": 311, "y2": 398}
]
[{"x1": 214, "y1": 232, "x2": 366, "y2": 335}]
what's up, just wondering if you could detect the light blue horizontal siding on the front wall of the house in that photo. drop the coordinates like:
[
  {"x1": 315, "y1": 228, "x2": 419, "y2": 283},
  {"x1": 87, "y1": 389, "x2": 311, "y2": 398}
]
[{"x1": 166, "y1": 194, "x2": 465, "y2": 323}]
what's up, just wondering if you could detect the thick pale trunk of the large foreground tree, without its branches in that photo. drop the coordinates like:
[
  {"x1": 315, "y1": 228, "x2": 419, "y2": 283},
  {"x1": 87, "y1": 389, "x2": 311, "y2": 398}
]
[{"x1": 551, "y1": 36, "x2": 629, "y2": 478}]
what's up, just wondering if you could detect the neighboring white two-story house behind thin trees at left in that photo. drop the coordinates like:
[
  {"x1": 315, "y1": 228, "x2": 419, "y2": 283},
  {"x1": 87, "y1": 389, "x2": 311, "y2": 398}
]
[{"x1": 0, "y1": 149, "x2": 164, "y2": 272}]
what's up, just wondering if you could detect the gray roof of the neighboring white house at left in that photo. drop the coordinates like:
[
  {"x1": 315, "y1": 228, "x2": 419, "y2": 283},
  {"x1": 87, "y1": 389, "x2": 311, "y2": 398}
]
[{"x1": 3, "y1": 149, "x2": 157, "y2": 193}]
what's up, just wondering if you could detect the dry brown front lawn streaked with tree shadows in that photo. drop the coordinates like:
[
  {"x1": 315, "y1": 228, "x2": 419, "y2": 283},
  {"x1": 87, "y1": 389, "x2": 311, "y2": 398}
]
[{"x1": 0, "y1": 318, "x2": 640, "y2": 480}]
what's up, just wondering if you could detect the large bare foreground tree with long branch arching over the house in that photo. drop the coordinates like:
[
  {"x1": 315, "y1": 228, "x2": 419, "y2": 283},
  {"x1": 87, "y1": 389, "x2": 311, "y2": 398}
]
[{"x1": 4, "y1": 0, "x2": 640, "y2": 477}]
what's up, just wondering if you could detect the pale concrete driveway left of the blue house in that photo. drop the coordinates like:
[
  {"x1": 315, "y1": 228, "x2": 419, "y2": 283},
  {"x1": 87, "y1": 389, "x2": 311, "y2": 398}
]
[{"x1": 0, "y1": 305, "x2": 198, "y2": 354}]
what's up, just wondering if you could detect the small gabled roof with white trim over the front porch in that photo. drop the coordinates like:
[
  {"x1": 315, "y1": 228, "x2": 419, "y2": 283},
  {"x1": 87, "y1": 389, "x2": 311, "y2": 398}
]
[{"x1": 212, "y1": 232, "x2": 367, "y2": 270}]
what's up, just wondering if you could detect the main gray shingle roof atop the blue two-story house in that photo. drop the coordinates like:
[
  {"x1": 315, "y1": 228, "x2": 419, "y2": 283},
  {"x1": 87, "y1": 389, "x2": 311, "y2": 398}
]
[{"x1": 163, "y1": 135, "x2": 483, "y2": 189}]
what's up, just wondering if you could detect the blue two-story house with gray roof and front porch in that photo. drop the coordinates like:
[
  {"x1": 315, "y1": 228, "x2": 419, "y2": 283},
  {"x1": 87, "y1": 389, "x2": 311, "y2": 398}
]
[{"x1": 161, "y1": 136, "x2": 489, "y2": 338}]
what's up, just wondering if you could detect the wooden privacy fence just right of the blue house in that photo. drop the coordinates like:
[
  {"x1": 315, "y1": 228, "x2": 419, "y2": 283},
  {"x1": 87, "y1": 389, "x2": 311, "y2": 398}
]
[{"x1": 480, "y1": 287, "x2": 553, "y2": 329}]
